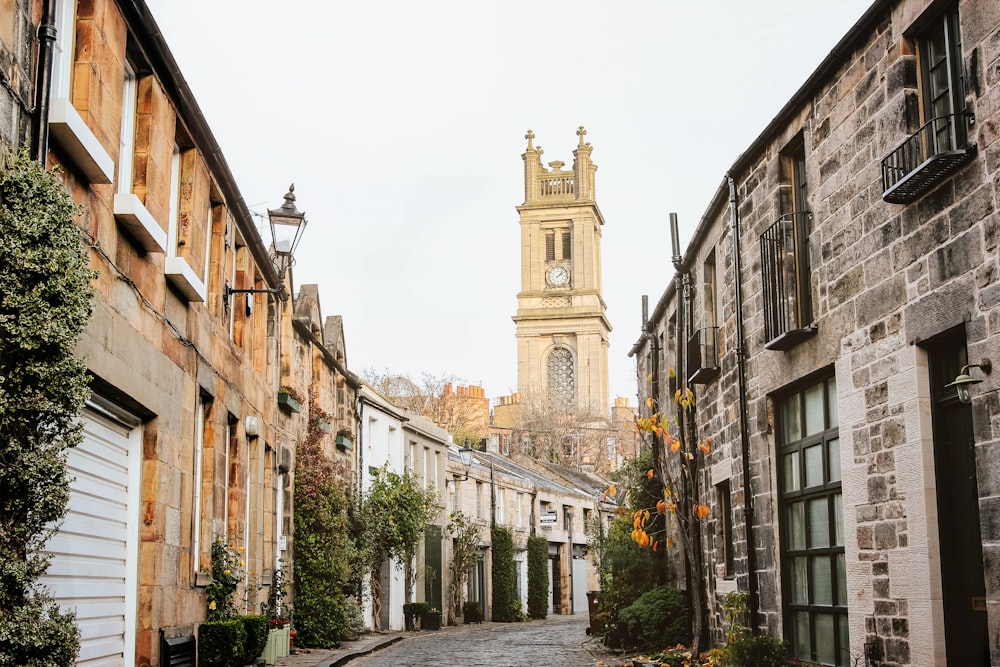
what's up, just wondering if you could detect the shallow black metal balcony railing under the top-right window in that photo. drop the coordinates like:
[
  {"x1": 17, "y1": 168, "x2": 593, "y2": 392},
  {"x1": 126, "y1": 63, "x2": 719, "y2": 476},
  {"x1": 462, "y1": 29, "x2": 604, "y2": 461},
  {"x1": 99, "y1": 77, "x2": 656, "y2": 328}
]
[{"x1": 882, "y1": 113, "x2": 976, "y2": 204}]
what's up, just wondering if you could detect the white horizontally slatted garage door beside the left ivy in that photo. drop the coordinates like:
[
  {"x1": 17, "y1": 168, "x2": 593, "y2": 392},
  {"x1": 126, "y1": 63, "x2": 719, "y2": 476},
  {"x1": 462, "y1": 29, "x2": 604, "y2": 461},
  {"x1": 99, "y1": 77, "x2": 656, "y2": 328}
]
[{"x1": 42, "y1": 404, "x2": 140, "y2": 667}]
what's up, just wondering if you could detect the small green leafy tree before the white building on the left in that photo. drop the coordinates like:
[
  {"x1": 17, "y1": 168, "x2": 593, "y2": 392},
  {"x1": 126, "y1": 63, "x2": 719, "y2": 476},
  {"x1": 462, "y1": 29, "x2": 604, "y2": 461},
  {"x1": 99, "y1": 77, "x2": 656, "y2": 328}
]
[{"x1": 356, "y1": 466, "x2": 441, "y2": 630}]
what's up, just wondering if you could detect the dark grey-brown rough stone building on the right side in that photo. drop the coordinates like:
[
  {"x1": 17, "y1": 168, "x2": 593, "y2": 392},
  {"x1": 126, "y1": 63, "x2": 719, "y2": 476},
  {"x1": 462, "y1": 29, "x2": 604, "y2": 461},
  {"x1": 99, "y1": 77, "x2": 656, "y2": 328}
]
[{"x1": 632, "y1": 0, "x2": 1000, "y2": 666}]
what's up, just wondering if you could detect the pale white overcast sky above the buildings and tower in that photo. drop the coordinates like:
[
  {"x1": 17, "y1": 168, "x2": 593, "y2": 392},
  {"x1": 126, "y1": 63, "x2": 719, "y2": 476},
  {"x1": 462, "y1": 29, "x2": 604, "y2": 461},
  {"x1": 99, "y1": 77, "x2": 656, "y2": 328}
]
[{"x1": 147, "y1": 0, "x2": 871, "y2": 405}]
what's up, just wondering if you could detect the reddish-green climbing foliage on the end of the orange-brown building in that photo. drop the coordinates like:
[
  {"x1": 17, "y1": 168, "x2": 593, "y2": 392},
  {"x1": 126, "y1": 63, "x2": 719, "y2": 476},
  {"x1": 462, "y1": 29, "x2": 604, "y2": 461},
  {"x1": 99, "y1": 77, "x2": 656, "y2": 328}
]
[{"x1": 292, "y1": 405, "x2": 356, "y2": 647}]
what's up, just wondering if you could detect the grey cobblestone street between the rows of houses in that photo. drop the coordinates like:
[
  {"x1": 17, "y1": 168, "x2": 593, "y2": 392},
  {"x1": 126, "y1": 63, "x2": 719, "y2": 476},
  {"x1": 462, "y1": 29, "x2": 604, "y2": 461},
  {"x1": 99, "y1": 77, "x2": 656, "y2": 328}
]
[{"x1": 350, "y1": 614, "x2": 617, "y2": 667}]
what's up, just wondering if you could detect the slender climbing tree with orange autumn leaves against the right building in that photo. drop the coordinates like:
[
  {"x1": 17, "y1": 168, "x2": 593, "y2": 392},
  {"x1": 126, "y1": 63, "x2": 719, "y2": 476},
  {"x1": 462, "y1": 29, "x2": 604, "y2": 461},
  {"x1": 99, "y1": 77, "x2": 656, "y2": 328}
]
[{"x1": 631, "y1": 386, "x2": 712, "y2": 653}]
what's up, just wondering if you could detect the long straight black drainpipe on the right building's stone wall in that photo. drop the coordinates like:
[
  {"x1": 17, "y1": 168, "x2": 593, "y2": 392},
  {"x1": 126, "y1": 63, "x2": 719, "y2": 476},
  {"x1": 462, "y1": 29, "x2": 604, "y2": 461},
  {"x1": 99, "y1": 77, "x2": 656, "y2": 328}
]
[{"x1": 726, "y1": 174, "x2": 759, "y2": 634}]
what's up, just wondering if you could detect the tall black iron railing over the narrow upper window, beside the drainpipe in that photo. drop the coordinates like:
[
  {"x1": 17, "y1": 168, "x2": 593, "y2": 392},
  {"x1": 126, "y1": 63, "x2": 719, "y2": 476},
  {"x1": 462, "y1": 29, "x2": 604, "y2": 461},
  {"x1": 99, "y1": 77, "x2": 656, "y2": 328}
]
[{"x1": 760, "y1": 211, "x2": 815, "y2": 350}]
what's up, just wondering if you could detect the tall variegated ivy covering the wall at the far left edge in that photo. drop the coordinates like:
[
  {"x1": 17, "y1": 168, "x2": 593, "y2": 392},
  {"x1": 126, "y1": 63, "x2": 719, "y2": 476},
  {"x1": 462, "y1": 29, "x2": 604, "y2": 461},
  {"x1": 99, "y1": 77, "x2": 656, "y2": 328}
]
[{"x1": 0, "y1": 149, "x2": 96, "y2": 667}]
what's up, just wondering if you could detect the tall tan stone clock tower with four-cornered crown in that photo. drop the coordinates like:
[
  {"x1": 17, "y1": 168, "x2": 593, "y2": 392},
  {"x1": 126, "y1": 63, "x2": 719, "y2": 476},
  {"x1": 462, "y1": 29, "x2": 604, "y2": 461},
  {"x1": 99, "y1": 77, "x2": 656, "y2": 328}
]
[{"x1": 513, "y1": 127, "x2": 611, "y2": 416}]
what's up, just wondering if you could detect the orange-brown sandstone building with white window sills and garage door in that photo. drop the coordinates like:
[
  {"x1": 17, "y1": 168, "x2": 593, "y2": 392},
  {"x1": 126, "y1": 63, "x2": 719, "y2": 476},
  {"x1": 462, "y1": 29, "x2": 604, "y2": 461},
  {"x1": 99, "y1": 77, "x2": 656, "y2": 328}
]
[{"x1": 0, "y1": 0, "x2": 357, "y2": 665}]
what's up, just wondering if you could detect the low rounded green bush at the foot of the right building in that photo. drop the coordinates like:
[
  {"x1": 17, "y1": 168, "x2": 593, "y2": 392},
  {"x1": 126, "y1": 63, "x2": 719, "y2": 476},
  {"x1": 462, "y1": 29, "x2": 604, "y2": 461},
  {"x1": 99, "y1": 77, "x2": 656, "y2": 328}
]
[{"x1": 611, "y1": 586, "x2": 691, "y2": 651}]
